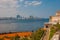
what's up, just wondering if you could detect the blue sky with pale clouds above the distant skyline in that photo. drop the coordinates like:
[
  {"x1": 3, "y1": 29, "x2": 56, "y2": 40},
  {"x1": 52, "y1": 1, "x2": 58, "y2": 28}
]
[{"x1": 0, "y1": 0, "x2": 60, "y2": 18}]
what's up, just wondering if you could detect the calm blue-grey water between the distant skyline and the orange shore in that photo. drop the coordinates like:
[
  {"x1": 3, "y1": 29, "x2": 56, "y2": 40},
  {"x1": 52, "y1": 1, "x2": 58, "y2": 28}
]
[{"x1": 0, "y1": 19, "x2": 49, "y2": 33}]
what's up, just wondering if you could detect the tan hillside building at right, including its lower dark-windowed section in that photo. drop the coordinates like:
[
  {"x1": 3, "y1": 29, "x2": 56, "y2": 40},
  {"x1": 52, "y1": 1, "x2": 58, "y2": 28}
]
[{"x1": 44, "y1": 11, "x2": 60, "y2": 28}]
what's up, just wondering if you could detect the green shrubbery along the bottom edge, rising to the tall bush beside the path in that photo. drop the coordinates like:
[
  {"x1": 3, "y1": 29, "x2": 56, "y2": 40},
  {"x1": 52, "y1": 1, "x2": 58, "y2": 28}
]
[{"x1": 0, "y1": 28, "x2": 44, "y2": 40}]
